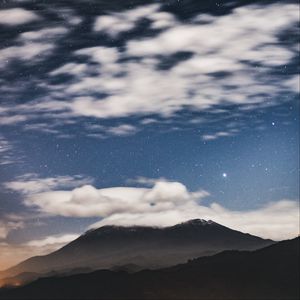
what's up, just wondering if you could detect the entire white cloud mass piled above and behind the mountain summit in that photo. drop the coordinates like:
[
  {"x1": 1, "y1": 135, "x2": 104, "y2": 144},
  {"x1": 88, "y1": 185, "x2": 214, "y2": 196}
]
[{"x1": 24, "y1": 180, "x2": 299, "y2": 240}]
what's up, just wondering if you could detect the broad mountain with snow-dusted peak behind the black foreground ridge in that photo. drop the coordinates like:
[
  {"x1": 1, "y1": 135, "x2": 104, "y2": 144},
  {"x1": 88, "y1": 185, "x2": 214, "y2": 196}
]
[{"x1": 0, "y1": 219, "x2": 273, "y2": 278}]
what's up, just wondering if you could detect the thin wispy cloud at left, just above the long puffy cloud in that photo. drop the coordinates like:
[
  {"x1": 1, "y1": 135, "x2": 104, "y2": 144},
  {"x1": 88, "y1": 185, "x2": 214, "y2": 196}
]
[{"x1": 3, "y1": 173, "x2": 93, "y2": 194}]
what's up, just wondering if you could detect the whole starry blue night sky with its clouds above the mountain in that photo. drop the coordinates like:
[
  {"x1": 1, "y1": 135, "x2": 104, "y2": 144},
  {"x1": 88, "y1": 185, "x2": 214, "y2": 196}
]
[{"x1": 0, "y1": 0, "x2": 299, "y2": 269}]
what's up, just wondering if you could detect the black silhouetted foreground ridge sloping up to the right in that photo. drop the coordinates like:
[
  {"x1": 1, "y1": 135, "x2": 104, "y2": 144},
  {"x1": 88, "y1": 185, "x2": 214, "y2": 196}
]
[{"x1": 0, "y1": 238, "x2": 300, "y2": 300}]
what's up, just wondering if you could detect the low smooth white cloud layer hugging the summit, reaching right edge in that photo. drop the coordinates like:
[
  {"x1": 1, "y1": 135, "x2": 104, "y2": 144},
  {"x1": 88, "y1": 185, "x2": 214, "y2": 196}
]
[{"x1": 91, "y1": 200, "x2": 299, "y2": 240}]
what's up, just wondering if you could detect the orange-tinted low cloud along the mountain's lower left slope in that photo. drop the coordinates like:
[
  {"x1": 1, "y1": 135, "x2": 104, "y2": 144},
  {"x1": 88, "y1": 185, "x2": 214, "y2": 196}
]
[{"x1": 0, "y1": 233, "x2": 79, "y2": 270}]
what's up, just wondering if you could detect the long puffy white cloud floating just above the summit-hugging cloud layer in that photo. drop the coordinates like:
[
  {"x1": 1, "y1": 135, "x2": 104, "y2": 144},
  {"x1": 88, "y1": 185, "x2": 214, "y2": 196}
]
[{"x1": 25, "y1": 182, "x2": 208, "y2": 217}]
